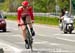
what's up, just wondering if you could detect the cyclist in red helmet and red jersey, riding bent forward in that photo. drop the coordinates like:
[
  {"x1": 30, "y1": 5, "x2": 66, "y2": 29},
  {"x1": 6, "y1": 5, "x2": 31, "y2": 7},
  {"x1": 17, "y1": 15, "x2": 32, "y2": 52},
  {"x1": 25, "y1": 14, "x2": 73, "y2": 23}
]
[{"x1": 17, "y1": 1, "x2": 35, "y2": 44}]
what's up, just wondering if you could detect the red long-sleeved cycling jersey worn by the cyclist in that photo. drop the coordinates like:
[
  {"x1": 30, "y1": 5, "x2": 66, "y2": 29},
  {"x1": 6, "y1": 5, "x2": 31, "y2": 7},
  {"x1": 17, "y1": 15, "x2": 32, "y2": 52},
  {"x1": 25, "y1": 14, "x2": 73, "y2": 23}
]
[{"x1": 17, "y1": 6, "x2": 34, "y2": 23}]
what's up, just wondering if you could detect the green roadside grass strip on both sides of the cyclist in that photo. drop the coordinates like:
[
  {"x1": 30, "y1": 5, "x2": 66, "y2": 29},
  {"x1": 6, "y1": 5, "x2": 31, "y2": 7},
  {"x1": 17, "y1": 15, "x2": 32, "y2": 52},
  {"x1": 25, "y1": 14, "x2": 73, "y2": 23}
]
[{"x1": 7, "y1": 16, "x2": 59, "y2": 25}]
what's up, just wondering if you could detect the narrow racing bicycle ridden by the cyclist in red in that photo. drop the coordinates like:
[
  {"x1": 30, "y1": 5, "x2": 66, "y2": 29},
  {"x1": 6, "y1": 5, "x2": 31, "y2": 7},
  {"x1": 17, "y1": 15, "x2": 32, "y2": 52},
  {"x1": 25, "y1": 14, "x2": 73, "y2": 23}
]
[{"x1": 22, "y1": 16, "x2": 33, "y2": 51}]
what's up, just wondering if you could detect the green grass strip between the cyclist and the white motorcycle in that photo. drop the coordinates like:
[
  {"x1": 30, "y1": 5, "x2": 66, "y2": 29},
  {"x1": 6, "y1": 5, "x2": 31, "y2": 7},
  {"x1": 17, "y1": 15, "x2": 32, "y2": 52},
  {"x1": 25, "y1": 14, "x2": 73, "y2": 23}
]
[{"x1": 35, "y1": 16, "x2": 58, "y2": 25}]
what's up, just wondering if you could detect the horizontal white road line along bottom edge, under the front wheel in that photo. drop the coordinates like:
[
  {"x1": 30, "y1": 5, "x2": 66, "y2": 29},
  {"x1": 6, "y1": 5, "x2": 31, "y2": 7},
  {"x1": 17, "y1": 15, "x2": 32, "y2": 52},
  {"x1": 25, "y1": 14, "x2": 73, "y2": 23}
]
[{"x1": 22, "y1": 48, "x2": 70, "y2": 53}]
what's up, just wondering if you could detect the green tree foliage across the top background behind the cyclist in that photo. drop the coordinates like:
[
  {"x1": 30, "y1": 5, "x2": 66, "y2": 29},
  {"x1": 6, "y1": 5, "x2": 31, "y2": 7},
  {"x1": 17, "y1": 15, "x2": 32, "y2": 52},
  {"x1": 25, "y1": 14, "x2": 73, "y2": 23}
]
[{"x1": 0, "y1": 0, "x2": 69, "y2": 13}]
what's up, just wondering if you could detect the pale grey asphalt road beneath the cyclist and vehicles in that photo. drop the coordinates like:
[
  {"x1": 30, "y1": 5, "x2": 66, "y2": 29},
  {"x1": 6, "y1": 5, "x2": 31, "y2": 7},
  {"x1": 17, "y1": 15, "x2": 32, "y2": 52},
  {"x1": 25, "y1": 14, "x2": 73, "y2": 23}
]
[{"x1": 0, "y1": 21, "x2": 75, "y2": 53}]
